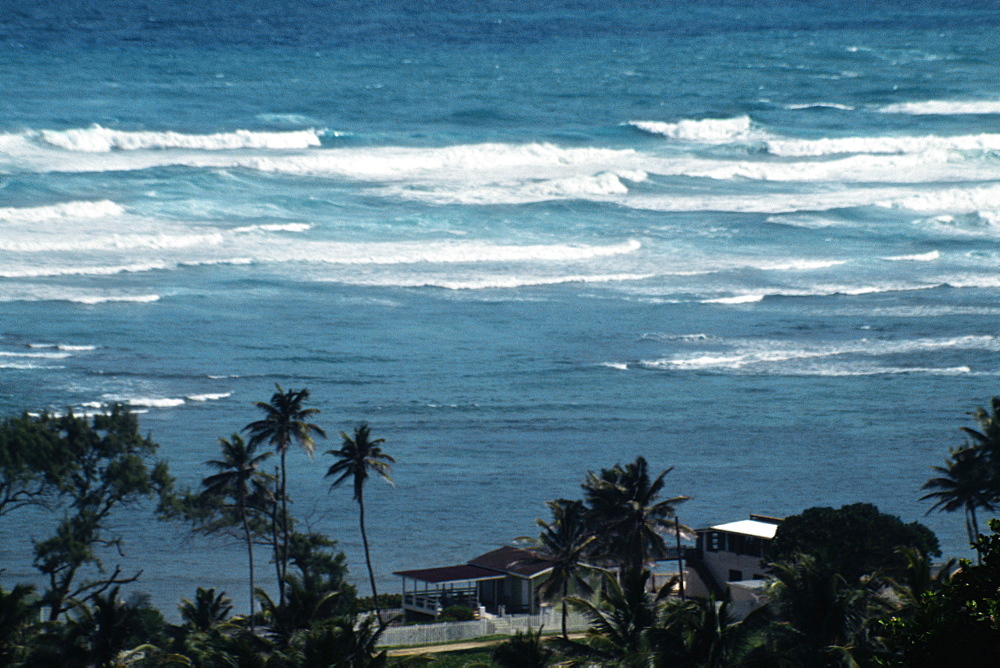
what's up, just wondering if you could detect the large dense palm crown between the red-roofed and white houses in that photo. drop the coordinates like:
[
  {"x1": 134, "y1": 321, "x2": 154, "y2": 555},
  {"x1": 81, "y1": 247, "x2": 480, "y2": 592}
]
[{"x1": 582, "y1": 457, "x2": 689, "y2": 570}]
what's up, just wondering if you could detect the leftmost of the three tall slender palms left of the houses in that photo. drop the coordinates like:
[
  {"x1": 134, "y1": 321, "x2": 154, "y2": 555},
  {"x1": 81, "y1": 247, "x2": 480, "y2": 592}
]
[{"x1": 199, "y1": 434, "x2": 271, "y2": 632}]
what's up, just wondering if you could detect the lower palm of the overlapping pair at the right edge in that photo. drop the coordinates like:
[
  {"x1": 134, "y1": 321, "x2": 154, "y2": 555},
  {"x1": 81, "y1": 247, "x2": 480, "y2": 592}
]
[{"x1": 920, "y1": 445, "x2": 997, "y2": 544}]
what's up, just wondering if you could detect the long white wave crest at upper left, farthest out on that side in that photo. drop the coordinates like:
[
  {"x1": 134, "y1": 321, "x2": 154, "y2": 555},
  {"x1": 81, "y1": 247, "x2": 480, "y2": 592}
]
[{"x1": 38, "y1": 125, "x2": 320, "y2": 153}]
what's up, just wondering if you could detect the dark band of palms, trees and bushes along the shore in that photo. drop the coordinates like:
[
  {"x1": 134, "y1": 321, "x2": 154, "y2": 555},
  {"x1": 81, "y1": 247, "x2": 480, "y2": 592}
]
[{"x1": 0, "y1": 394, "x2": 1000, "y2": 668}]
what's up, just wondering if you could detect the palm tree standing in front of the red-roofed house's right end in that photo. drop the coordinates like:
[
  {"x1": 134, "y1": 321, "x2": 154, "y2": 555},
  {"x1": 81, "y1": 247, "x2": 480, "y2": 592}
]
[{"x1": 526, "y1": 499, "x2": 596, "y2": 640}]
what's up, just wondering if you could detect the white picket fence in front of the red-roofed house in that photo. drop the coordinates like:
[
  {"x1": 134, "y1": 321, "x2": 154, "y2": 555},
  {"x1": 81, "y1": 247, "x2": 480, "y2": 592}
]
[{"x1": 379, "y1": 607, "x2": 587, "y2": 646}]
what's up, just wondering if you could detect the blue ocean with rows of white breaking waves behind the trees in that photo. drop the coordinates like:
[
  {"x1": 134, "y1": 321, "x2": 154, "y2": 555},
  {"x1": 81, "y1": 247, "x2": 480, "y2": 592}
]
[{"x1": 0, "y1": 0, "x2": 1000, "y2": 610}]
